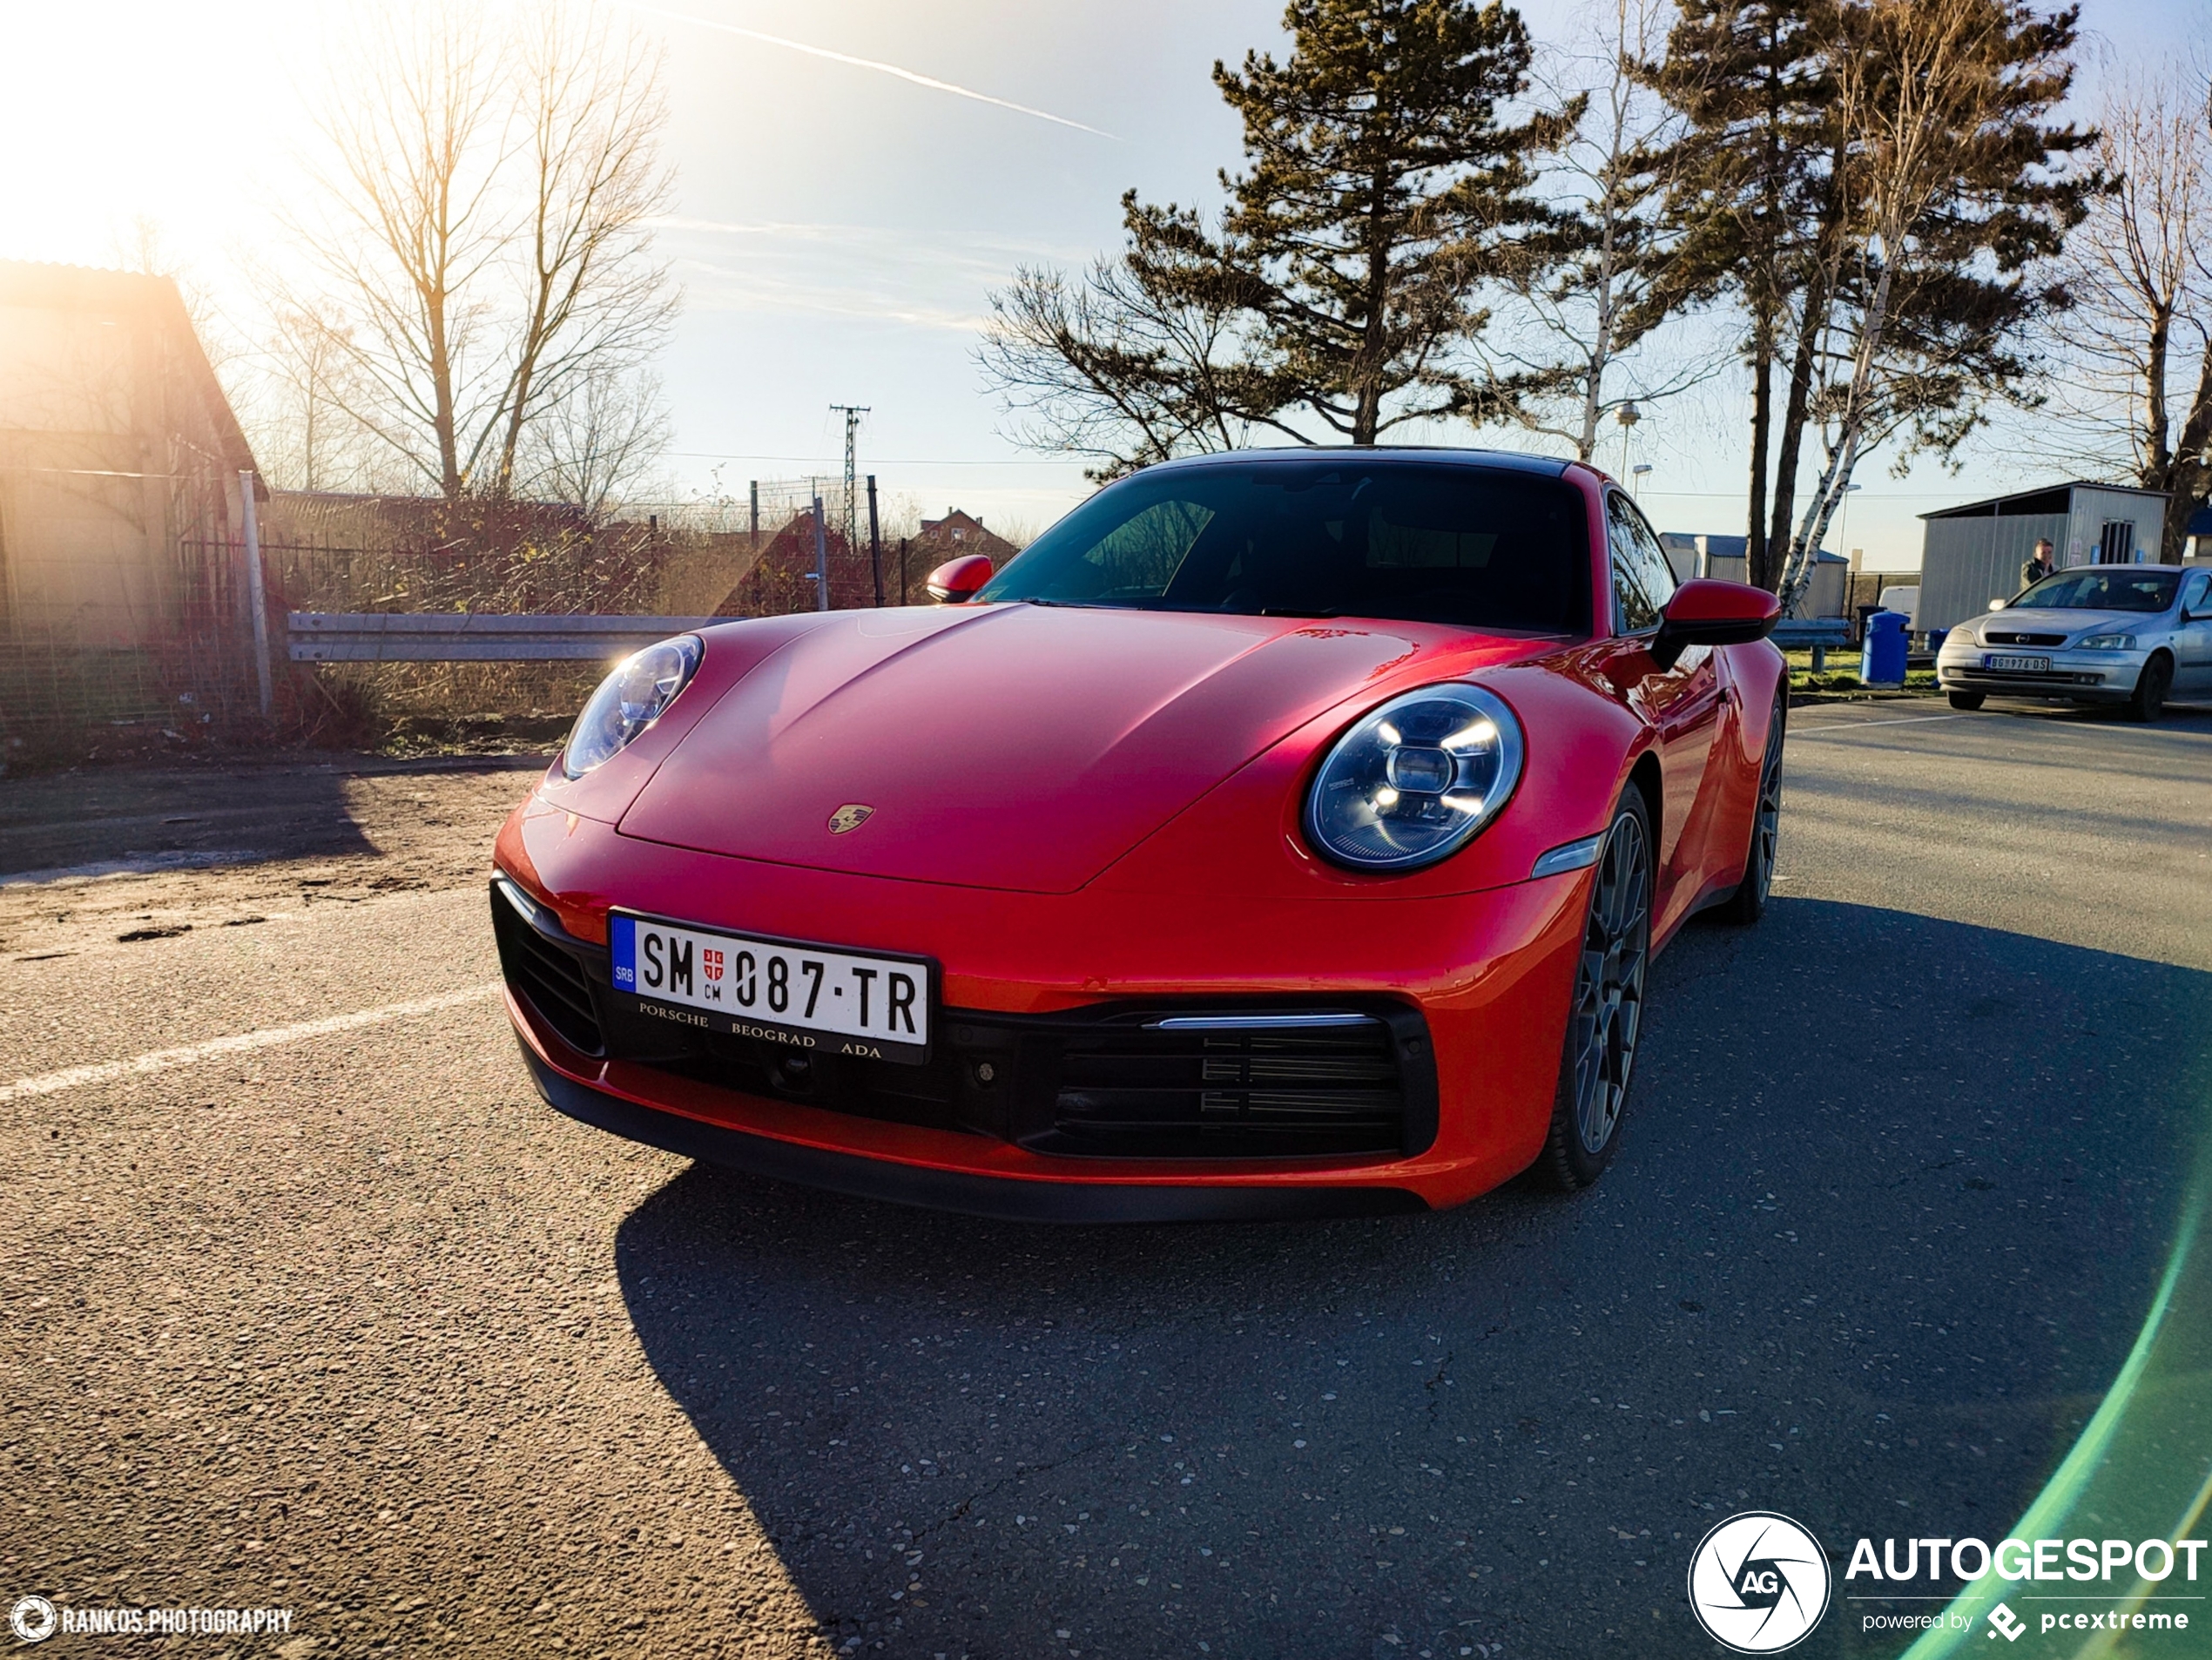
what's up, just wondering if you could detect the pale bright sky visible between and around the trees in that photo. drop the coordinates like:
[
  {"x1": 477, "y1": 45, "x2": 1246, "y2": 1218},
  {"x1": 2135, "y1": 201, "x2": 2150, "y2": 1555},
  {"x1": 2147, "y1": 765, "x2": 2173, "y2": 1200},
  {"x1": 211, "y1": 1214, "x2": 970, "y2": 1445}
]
[{"x1": 0, "y1": 0, "x2": 2205, "y2": 569}]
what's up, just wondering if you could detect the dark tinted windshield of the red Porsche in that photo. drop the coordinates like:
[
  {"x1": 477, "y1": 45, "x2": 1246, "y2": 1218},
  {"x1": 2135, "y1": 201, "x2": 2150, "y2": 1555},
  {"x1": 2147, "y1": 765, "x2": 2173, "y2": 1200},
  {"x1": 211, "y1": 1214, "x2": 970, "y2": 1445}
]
[{"x1": 978, "y1": 458, "x2": 1590, "y2": 635}]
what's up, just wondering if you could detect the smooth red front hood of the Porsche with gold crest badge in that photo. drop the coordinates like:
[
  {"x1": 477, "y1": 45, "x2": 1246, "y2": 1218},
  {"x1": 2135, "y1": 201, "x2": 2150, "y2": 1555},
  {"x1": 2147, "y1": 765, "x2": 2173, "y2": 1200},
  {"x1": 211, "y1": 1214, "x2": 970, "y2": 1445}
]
[{"x1": 622, "y1": 604, "x2": 1541, "y2": 892}]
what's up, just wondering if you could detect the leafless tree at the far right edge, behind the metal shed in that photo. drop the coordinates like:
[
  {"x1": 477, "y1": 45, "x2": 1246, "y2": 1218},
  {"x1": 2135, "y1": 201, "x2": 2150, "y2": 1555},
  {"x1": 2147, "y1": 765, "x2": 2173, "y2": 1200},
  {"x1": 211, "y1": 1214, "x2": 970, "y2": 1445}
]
[{"x1": 2031, "y1": 66, "x2": 2212, "y2": 562}]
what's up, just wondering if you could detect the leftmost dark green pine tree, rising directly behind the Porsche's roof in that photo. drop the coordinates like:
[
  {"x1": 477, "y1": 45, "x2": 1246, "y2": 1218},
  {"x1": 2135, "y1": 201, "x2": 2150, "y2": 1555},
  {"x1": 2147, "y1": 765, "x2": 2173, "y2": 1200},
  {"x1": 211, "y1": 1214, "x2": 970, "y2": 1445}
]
[{"x1": 982, "y1": 0, "x2": 1580, "y2": 474}]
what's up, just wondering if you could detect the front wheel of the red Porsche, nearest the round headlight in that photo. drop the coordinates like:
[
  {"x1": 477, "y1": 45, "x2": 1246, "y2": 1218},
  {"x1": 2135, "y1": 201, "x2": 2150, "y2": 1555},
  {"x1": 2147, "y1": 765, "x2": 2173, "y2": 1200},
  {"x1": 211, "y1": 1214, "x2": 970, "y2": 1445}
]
[{"x1": 1537, "y1": 788, "x2": 1652, "y2": 1193}]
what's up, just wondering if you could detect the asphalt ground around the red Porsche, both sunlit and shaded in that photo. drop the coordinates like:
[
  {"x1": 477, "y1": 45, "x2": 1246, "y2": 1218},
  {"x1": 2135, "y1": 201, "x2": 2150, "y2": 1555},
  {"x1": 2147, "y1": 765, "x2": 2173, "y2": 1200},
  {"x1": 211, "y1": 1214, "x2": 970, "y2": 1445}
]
[{"x1": 0, "y1": 702, "x2": 2212, "y2": 1660}]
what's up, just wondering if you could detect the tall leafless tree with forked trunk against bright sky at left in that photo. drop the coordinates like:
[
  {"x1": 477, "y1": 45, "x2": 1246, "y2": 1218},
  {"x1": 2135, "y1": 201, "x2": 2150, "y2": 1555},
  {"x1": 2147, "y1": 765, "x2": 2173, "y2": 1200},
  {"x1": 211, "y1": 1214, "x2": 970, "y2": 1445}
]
[{"x1": 281, "y1": 0, "x2": 675, "y2": 498}]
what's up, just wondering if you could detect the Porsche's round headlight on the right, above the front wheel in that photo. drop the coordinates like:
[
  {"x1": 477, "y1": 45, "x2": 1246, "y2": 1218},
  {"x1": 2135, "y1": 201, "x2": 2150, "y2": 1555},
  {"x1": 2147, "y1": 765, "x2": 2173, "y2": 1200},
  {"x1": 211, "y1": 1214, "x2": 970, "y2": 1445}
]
[{"x1": 1305, "y1": 682, "x2": 1522, "y2": 870}]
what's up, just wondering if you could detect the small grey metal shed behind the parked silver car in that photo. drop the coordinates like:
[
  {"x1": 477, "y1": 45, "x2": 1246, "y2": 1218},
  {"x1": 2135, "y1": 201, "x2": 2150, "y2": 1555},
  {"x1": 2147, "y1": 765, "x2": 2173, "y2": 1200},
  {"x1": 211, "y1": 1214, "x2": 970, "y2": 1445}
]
[{"x1": 1918, "y1": 480, "x2": 2166, "y2": 629}]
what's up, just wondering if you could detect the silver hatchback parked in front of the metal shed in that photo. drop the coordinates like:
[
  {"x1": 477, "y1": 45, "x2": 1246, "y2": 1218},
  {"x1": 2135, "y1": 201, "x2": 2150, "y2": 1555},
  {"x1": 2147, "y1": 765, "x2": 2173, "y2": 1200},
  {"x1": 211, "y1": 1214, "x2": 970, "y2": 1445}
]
[{"x1": 1936, "y1": 564, "x2": 2212, "y2": 721}]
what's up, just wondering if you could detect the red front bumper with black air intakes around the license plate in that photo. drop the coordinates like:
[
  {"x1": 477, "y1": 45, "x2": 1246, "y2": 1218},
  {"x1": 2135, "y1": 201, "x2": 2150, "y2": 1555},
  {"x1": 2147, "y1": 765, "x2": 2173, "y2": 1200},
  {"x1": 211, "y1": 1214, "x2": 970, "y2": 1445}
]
[{"x1": 493, "y1": 808, "x2": 1588, "y2": 1219}]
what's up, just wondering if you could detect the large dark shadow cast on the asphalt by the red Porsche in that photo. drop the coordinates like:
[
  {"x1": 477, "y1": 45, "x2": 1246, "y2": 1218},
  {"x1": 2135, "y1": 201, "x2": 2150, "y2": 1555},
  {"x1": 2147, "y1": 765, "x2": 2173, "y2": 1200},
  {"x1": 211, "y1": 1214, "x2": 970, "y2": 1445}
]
[{"x1": 615, "y1": 899, "x2": 2212, "y2": 1660}]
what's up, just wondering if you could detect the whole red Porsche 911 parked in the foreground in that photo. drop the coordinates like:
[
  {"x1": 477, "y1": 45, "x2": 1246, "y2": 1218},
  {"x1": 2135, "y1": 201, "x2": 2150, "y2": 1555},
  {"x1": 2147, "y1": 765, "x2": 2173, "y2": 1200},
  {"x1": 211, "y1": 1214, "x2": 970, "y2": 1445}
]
[{"x1": 491, "y1": 449, "x2": 1785, "y2": 1222}]
